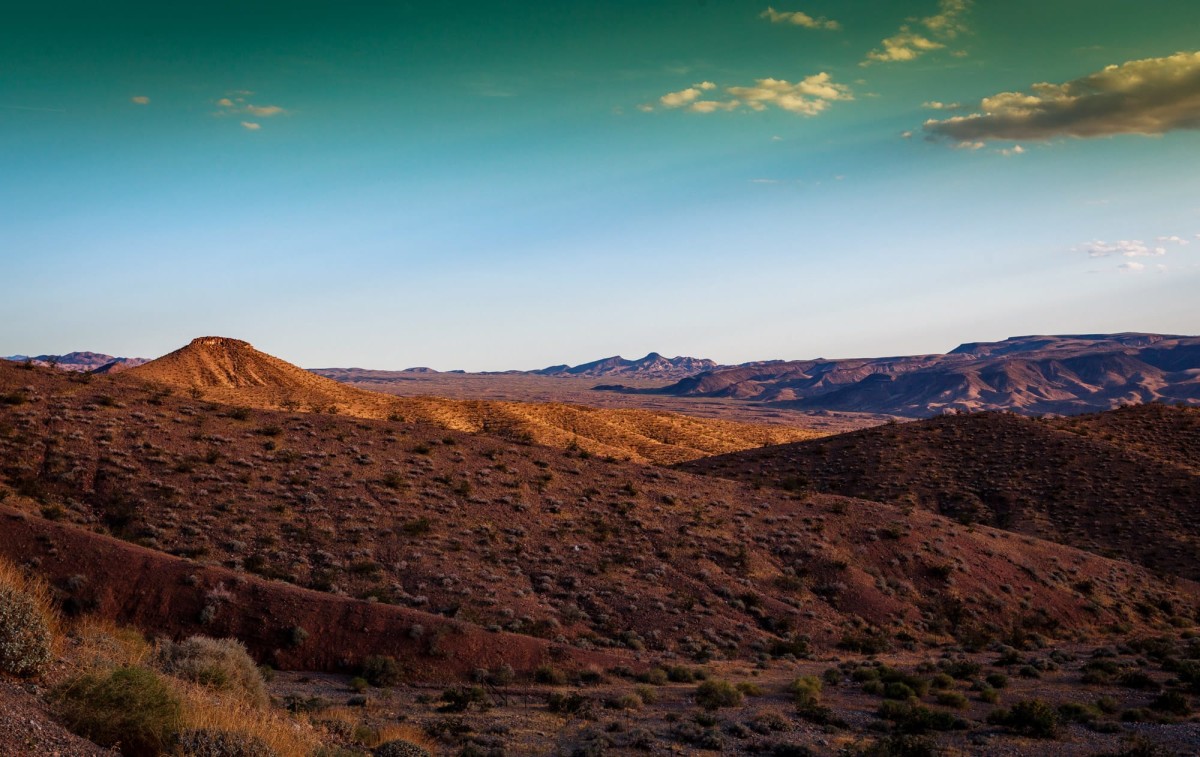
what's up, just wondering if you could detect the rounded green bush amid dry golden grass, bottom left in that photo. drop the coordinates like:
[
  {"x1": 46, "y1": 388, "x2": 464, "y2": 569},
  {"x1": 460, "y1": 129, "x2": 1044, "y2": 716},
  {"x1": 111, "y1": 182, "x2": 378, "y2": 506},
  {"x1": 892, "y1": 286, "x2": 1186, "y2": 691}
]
[{"x1": 53, "y1": 667, "x2": 181, "y2": 757}]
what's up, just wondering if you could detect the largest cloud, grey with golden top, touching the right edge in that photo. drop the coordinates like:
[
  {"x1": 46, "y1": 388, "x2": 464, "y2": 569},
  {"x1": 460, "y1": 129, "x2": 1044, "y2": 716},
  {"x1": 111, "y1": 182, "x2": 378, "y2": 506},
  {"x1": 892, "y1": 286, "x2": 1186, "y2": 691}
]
[{"x1": 925, "y1": 52, "x2": 1200, "y2": 142}]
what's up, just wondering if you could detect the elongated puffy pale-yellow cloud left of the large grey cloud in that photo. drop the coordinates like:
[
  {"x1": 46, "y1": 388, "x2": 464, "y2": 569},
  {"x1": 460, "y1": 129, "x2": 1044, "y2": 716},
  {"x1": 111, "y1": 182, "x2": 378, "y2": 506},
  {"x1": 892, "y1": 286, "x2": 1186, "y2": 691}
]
[{"x1": 659, "y1": 72, "x2": 854, "y2": 115}]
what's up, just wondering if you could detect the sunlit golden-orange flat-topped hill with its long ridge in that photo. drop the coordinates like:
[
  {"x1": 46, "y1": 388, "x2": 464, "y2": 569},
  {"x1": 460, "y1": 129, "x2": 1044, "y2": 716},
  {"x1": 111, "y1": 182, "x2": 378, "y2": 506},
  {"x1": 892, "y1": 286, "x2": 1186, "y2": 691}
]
[{"x1": 125, "y1": 337, "x2": 818, "y2": 463}]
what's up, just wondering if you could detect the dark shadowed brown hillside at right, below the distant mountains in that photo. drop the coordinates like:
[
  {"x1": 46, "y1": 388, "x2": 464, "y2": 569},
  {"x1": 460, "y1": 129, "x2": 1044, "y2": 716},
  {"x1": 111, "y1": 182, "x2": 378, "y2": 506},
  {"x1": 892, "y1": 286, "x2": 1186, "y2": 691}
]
[{"x1": 680, "y1": 405, "x2": 1200, "y2": 578}]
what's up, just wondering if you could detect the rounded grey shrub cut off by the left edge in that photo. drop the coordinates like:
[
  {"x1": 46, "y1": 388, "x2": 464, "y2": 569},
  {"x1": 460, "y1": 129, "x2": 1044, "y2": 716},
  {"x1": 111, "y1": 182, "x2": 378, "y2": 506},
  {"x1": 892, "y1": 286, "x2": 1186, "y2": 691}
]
[{"x1": 0, "y1": 558, "x2": 58, "y2": 678}]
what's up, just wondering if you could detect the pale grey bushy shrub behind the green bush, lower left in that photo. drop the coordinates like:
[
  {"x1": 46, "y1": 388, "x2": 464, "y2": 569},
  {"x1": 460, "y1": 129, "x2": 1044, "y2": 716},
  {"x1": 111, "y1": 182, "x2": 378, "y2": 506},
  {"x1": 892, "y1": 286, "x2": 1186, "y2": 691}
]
[{"x1": 154, "y1": 636, "x2": 270, "y2": 707}]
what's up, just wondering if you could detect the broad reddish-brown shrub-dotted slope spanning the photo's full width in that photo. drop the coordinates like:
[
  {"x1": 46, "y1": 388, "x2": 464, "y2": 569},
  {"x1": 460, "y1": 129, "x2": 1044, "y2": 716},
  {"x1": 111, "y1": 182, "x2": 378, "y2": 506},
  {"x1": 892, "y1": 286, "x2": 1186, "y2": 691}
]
[{"x1": 0, "y1": 366, "x2": 1198, "y2": 659}]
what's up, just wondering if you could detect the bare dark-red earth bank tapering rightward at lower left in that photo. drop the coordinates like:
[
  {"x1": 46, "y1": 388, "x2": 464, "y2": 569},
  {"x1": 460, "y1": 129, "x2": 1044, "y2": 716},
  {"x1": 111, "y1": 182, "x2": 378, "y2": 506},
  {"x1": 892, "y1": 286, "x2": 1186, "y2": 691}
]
[{"x1": 0, "y1": 506, "x2": 637, "y2": 680}]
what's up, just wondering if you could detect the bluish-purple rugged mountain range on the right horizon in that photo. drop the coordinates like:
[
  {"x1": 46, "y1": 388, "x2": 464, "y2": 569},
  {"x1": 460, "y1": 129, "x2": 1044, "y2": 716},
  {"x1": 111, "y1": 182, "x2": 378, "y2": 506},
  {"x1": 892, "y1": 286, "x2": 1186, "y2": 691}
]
[{"x1": 609, "y1": 334, "x2": 1200, "y2": 417}]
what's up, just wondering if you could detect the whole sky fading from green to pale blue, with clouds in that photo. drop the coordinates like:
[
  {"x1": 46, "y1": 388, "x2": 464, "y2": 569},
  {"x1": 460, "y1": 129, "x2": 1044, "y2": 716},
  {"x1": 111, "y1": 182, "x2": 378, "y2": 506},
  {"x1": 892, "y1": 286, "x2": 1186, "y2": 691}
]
[{"x1": 0, "y1": 0, "x2": 1200, "y2": 371}]
